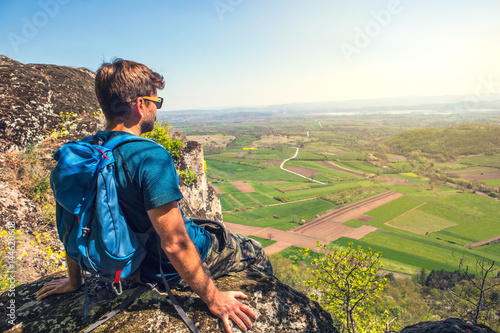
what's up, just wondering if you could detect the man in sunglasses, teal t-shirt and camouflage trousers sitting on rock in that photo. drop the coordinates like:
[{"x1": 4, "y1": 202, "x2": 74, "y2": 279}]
[{"x1": 36, "y1": 59, "x2": 272, "y2": 332}]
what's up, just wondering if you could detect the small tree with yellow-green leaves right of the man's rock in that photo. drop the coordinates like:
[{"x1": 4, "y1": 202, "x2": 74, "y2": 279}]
[{"x1": 303, "y1": 242, "x2": 388, "y2": 333}]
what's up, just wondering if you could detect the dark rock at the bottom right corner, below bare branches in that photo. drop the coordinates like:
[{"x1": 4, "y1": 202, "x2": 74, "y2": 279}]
[{"x1": 400, "y1": 318, "x2": 495, "y2": 333}]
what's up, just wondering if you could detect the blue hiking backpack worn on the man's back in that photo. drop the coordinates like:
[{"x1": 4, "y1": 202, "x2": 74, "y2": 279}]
[{"x1": 50, "y1": 134, "x2": 157, "y2": 295}]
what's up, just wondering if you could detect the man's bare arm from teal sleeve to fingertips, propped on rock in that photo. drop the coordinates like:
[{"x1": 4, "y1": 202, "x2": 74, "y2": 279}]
[{"x1": 148, "y1": 201, "x2": 257, "y2": 333}]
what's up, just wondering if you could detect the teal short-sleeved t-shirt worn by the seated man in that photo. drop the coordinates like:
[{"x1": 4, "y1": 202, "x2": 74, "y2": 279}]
[{"x1": 93, "y1": 131, "x2": 211, "y2": 281}]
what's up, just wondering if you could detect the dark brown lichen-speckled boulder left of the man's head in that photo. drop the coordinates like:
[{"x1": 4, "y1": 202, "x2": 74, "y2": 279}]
[{"x1": 0, "y1": 55, "x2": 102, "y2": 152}]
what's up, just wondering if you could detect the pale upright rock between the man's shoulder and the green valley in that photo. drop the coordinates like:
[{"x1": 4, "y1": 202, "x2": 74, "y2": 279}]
[{"x1": 175, "y1": 141, "x2": 222, "y2": 222}]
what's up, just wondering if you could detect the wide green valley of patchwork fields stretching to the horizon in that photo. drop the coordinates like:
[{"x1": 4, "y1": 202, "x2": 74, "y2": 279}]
[{"x1": 162, "y1": 109, "x2": 500, "y2": 277}]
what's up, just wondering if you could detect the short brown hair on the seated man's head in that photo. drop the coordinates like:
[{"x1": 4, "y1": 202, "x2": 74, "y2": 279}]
[{"x1": 95, "y1": 59, "x2": 165, "y2": 121}]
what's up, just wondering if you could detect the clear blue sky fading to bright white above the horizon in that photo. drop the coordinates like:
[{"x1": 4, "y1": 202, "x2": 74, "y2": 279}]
[{"x1": 0, "y1": 0, "x2": 500, "y2": 111}]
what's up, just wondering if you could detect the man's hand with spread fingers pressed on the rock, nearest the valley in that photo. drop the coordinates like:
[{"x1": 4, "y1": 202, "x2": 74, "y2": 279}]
[{"x1": 208, "y1": 291, "x2": 257, "y2": 333}]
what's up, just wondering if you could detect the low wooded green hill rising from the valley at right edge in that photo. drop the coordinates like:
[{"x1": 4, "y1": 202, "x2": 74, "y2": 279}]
[{"x1": 383, "y1": 124, "x2": 500, "y2": 158}]
